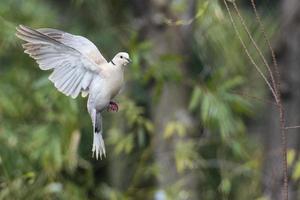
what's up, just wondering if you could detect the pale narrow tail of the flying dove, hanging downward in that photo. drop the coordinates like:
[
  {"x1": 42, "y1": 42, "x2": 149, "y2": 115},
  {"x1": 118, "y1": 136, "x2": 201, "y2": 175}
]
[{"x1": 92, "y1": 110, "x2": 106, "y2": 160}]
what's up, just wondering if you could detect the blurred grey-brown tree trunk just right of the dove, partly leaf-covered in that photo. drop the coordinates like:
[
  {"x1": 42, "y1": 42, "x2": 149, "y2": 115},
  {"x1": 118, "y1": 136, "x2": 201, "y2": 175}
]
[{"x1": 133, "y1": 0, "x2": 199, "y2": 199}]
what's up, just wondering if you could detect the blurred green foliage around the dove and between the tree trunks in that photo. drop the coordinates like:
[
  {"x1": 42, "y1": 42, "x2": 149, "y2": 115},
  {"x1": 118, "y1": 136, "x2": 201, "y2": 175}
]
[{"x1": 0, "y1": 0, "x2": 278, "y2": 200}]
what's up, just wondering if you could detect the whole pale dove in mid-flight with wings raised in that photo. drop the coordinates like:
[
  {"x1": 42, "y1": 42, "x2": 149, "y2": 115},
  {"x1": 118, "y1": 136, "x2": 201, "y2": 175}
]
[{"x1": 16, "y1": 25, "x2": 131, "y2": 160}]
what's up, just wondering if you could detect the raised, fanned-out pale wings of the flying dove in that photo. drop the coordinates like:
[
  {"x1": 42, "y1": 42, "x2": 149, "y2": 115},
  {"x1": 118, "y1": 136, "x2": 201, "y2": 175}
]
[{"x1": 16, "y1": 25, "x2": 107, "y2": 98}]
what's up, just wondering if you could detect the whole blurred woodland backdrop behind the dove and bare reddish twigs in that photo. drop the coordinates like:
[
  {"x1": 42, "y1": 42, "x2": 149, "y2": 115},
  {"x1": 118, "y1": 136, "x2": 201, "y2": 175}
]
[{"x1": 0, "y1": 0, "x2": 300, "y2": 200}]
